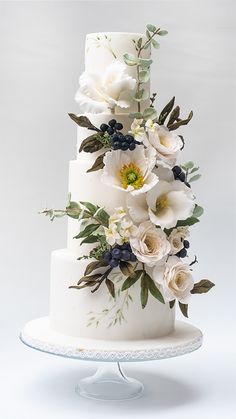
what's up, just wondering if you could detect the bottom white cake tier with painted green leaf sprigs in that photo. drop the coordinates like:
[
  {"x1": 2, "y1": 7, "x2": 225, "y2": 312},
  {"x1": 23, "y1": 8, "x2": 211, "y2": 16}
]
[{"x1": 50, "y1": 249, "x2": 175, "y2": 340}]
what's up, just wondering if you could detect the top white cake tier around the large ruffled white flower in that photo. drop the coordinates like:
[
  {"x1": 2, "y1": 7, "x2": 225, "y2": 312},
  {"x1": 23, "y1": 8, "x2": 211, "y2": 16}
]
[{"x1": 82, "y1": 32, "x2": 151, "y2": 114}]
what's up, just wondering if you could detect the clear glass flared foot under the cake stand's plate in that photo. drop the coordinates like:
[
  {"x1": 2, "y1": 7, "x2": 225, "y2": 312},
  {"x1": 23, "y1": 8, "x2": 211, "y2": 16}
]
[{"x1": 75, "y1": 362, "x2": 144, "y2": 401}]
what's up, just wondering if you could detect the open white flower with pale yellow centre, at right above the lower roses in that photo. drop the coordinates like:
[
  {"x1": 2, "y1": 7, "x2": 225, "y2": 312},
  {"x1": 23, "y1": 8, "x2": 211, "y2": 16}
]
[{"x1": 147, "y1": 180, "x2": 195, "y2": 228}]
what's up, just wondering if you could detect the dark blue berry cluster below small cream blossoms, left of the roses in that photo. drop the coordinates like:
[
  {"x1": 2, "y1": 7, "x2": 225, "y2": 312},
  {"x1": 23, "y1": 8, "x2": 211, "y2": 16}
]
[{"x1": 102, "y1": 243, "x2": 137, "y2": 268}]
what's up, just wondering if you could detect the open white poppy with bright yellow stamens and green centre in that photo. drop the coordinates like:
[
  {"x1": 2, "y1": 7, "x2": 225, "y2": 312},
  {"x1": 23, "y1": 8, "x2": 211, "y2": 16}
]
[{"x1": 101, "y1": 146, "x2": 158, "y2": 195}]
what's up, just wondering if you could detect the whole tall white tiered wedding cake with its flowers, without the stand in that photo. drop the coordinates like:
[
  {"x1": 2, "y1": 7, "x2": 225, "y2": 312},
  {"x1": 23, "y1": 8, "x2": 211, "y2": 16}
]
[{"x1": 42, "y1": 25, "x2": 213, "y2": 340}]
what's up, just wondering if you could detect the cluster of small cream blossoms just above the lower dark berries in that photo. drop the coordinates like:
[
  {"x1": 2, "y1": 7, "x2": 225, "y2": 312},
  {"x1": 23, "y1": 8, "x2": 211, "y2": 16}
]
[{"x1": 104, "y1": 207, "x2": 137, "y2": 246}]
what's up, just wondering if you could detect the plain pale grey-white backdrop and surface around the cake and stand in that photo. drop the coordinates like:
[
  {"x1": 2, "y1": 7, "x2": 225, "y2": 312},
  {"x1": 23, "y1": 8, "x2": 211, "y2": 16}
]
[{"x1": 0, "y1": 0, "x2": 236, "y2": 419}]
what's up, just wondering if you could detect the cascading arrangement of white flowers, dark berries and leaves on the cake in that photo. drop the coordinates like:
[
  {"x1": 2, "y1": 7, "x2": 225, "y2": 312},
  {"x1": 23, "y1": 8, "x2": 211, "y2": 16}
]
[{"x1": 42, "y1": 25, "x2": 214, "y2": 324}]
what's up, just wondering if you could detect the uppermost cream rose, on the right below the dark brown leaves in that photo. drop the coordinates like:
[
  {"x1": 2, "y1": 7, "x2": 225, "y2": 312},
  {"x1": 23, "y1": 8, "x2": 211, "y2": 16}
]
[{"x1": 146, "y1": 121, "x2": 183, "y2": 166}]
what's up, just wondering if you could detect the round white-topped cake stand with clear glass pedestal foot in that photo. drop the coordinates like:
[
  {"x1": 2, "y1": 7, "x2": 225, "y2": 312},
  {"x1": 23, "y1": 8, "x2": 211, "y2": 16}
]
[{"x1": 20, "y1": 317, "x2": 202, "y2": 400}]
